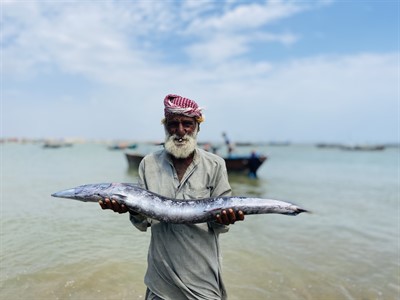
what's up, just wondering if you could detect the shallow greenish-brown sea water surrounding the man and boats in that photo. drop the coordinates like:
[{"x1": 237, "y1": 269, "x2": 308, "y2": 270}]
[{"x1": 0, "y1": 143, "x2": 400, "y2": 300}]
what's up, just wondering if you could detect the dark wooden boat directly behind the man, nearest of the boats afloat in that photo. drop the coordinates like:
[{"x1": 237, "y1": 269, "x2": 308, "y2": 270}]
[{"x1": 125, "y1": 153, "x2": 267, "y2": 177}]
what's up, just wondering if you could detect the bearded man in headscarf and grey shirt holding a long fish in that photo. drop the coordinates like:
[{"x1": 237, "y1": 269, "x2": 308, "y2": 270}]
[{"x1": 100, "y1": 95, "x2": 244, "y2": 300}]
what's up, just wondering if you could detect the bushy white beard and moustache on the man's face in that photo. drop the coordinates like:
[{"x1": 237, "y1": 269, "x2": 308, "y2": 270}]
[{"x1": 164, "y1": 130, "x2": 197, "y2": 158}]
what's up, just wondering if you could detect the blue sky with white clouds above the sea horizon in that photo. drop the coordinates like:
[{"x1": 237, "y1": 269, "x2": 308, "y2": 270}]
[{"x1": 0, "y1": 0, "x2": 400, "y2": 143}]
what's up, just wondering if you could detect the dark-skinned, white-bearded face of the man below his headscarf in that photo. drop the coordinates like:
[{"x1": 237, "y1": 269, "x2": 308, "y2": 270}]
[{"x1": 165, "y1": 115, "x2": 198, "y2": 158}]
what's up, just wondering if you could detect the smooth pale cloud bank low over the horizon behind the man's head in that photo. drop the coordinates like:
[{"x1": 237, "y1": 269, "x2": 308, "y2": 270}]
[{"x1": 4, "y1": 49, "x2": 398, "y2": 142}]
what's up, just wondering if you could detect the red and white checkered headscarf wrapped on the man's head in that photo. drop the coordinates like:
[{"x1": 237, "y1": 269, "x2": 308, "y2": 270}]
[{"x1": 164, "y1": 94, "x2": 203, "y2": 123}]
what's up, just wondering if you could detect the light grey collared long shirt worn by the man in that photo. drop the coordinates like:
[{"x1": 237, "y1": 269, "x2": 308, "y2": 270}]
[{"x1": 130, "y1": 149, "x2": 231, "y2": 300}]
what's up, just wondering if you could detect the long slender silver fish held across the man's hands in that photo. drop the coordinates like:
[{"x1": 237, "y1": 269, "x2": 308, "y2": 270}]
[{"x1": 52, "y1": 183, "x2": 307, "y2": 224}]
